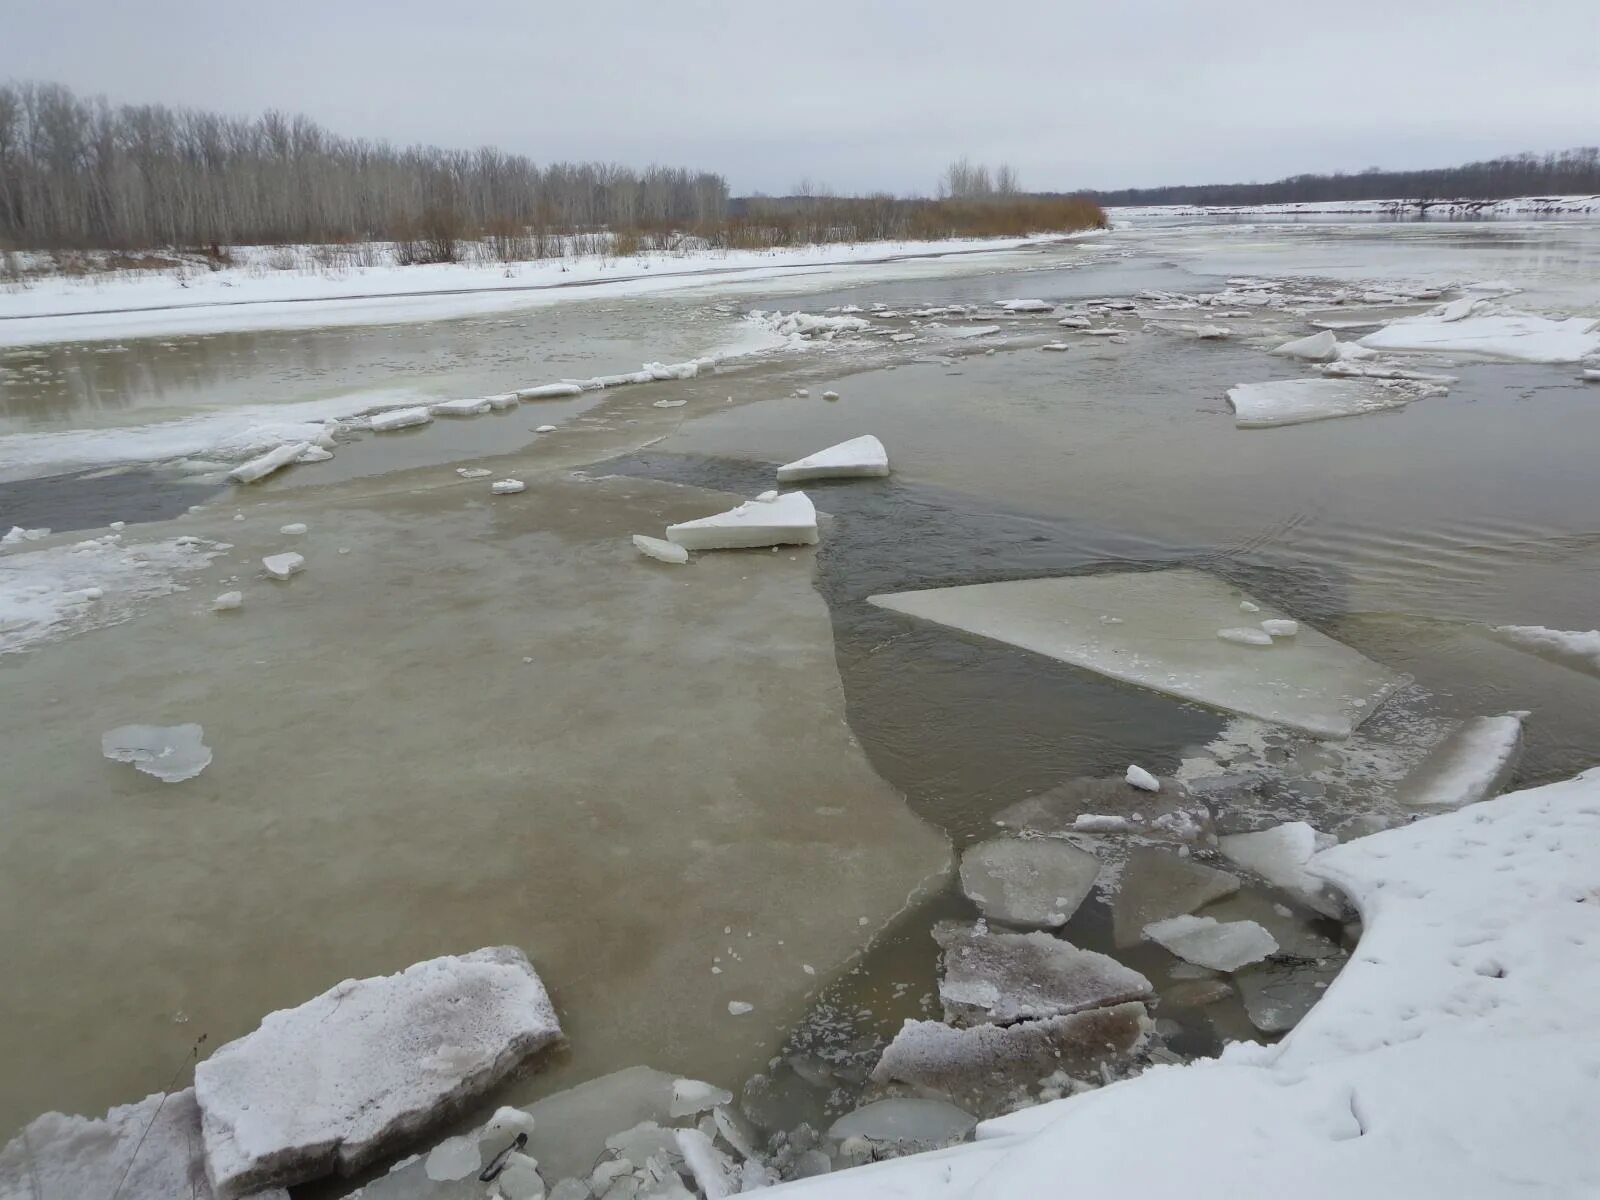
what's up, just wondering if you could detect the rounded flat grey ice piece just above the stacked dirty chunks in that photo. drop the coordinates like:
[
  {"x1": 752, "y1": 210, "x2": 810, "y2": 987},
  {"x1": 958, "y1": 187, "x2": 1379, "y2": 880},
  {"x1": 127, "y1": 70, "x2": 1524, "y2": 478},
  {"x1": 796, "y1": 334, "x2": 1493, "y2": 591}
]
[{"x1": 960, "y1": 837, "x2": 1099, "y2": 928}]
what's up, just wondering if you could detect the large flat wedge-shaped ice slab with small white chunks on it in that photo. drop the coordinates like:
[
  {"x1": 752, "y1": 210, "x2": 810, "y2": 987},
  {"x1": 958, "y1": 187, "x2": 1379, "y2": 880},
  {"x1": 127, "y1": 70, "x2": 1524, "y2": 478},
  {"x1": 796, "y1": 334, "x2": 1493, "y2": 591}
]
[{"x1": 869, "y1": 568, "x2": 1400, "y2": 738}]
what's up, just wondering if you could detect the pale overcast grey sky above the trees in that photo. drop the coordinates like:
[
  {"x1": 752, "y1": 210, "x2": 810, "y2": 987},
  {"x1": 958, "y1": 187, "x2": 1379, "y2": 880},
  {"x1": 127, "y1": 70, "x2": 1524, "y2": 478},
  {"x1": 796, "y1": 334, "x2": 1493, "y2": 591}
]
[{"x1": 0, "y1": 0, "x2": 1600, "y2": 192}]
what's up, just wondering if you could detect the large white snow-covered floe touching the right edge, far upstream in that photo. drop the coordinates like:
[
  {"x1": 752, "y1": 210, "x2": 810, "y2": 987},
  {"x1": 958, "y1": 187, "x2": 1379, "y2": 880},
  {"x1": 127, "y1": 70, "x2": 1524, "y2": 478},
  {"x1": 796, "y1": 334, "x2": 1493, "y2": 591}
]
[{"x1": 1360, "y1": 301, "x2": 1600, "y2": 363}]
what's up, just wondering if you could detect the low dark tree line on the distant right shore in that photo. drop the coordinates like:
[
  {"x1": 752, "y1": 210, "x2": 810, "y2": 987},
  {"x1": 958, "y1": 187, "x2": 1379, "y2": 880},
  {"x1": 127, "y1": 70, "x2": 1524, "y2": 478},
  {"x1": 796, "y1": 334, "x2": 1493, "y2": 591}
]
[{"x1": 1085, "y1": 146, "x2": 1600, "y2": 205}]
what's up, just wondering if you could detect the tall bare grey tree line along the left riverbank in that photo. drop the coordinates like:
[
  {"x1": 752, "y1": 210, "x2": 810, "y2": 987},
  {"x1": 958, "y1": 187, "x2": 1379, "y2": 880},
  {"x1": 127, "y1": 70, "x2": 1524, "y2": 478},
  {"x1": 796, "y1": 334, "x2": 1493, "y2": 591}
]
[{"x1": 0, "y1": 83, "x2": 728, "y2": 256}]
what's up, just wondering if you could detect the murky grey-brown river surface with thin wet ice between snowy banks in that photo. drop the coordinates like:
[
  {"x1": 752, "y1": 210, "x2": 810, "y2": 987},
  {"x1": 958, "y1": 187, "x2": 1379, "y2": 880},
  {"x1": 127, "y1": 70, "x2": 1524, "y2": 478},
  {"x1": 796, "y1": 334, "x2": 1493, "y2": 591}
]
[{"x1": 0, "y1": 222, "x2": 1600, "y2": 1177}]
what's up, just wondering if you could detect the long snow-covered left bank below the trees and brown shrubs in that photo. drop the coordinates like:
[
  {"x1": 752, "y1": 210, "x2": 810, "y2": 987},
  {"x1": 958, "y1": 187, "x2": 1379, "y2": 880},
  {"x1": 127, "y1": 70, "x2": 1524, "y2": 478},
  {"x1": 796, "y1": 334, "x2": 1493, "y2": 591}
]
[{"x1": 0, "y1": 230, "x2": 1075, "y2": 347}]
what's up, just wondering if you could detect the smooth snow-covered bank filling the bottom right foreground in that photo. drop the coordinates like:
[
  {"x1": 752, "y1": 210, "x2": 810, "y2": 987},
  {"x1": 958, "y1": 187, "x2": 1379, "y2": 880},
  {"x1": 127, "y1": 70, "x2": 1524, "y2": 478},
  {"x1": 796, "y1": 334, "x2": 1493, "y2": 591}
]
[{"x1": 761, "y1": 771, "x2": 1600, "y2": 1200}]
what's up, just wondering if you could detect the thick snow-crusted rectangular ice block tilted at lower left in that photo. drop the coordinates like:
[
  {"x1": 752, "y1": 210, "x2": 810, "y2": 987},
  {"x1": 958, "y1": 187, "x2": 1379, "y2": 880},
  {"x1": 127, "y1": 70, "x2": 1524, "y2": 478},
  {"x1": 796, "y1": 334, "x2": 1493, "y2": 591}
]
[{"x1": 195, "y1": 946, "x2": 562, "y2": 1200}]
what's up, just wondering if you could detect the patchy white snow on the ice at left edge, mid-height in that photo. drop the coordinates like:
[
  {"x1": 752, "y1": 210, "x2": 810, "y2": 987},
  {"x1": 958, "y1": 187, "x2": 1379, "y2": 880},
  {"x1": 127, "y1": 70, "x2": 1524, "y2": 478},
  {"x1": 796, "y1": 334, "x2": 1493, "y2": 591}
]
[{"x1": 0, "y1": 533, "x2": 229, "y2": 654}]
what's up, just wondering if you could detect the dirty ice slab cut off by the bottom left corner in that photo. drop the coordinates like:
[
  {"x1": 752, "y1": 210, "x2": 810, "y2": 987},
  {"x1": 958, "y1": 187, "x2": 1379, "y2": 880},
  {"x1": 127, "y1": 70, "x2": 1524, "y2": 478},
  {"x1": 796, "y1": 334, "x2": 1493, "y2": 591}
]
[{"x1": 0, "y1": 1088, "x2": 288, "y2": 1200}]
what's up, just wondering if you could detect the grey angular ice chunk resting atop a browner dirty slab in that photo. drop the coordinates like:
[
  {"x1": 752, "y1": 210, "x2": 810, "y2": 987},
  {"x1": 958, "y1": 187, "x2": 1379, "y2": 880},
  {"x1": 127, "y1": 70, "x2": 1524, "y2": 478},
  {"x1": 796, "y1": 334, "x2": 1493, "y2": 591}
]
[{"x1": 933, "y1": 922, "x2": 1150, "y2": 1026}]
